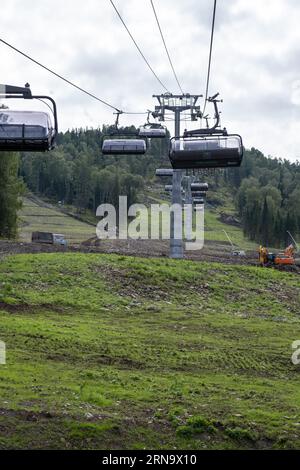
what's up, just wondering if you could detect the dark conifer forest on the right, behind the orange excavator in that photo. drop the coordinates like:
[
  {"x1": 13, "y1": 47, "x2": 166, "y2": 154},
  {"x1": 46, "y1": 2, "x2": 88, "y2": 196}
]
[{"x1": 227, "y1": 148, "x2": 300, "y2": 247}]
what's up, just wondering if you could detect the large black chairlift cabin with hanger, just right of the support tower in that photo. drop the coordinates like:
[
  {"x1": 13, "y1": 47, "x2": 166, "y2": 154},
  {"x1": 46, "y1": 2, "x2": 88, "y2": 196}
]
[{"x1": 169, "y1": 94, "x2": 243, "y2": 169}]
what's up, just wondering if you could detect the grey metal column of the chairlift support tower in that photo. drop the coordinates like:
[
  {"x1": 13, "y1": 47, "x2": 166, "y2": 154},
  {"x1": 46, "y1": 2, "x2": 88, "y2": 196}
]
[{"x1": 170, "y1": 109, "x2": 183, "y2": 259}]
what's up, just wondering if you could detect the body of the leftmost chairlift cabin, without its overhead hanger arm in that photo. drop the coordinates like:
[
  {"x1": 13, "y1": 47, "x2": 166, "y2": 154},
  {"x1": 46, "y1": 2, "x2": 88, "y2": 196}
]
[{"x1": 0, "y1": 110, "x2": 54, "y2": 152}]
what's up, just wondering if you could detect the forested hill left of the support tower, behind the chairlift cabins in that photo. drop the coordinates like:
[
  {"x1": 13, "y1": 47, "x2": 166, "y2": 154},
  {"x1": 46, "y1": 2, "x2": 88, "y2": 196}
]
[{"x1": 20, "y1": 127, "x2": 167, "y2": 213}]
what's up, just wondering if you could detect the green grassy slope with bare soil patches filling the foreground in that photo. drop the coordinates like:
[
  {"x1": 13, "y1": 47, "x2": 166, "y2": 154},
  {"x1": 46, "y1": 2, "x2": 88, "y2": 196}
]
[{"x1": 0, "y1": 253, "x2": 300, "y2": 449}]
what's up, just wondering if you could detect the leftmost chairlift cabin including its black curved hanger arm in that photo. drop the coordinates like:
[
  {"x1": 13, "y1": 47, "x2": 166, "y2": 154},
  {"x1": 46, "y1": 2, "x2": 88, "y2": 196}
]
[{"x1": 0, "y1": 84, "x2": 58, "y2": 152}]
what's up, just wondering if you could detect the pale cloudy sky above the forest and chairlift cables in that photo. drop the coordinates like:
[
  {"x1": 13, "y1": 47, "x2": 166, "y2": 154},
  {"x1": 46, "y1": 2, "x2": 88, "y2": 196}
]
[{"x1": 0, "y1": 0, "x2": 300, "y2": 161}]
